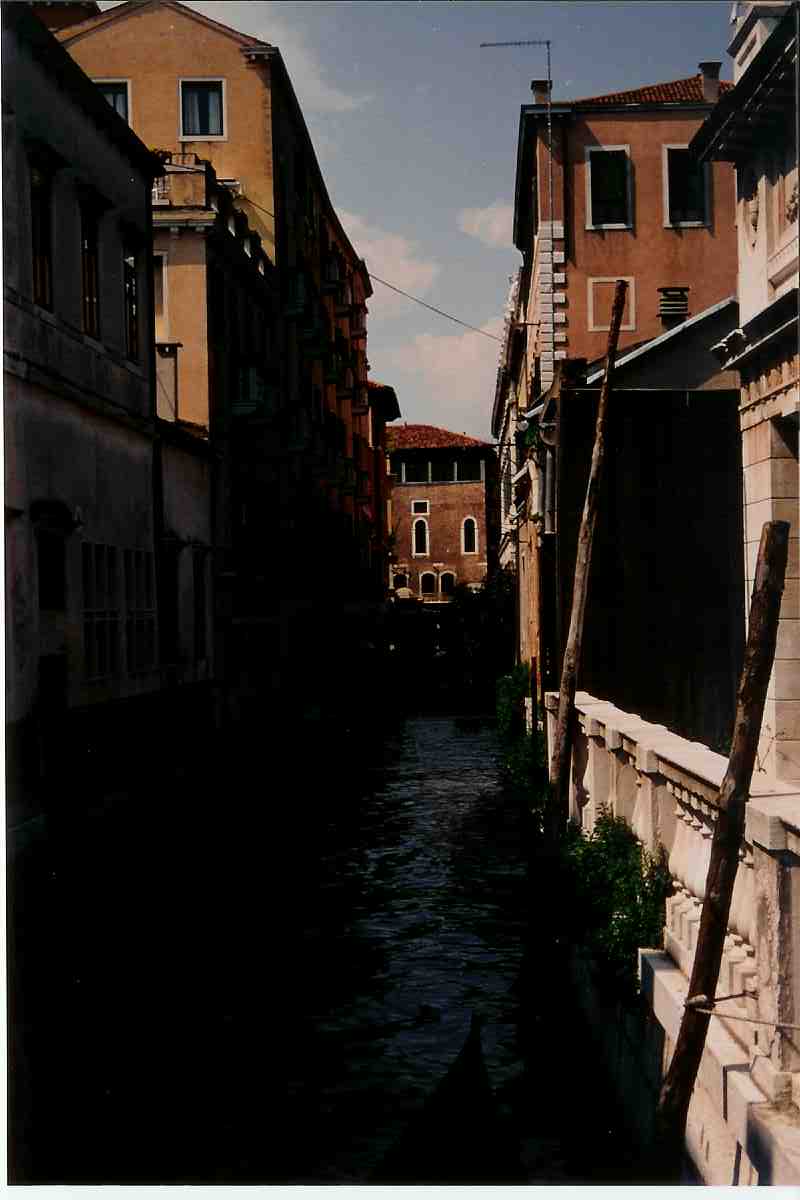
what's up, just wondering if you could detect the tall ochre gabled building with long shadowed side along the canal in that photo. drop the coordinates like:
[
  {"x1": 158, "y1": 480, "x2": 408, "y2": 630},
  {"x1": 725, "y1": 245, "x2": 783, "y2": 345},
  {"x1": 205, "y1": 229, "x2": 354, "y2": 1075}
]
[{"x1": 58, "y1": 0, "x2": 400, "y2": 710}]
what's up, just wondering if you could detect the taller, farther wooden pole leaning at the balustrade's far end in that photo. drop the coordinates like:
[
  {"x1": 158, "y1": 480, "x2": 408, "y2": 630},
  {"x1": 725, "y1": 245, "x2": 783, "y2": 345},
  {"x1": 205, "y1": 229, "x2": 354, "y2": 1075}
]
[{"x1": 547, "y1": 280, "x2": 627, "y2": 841}]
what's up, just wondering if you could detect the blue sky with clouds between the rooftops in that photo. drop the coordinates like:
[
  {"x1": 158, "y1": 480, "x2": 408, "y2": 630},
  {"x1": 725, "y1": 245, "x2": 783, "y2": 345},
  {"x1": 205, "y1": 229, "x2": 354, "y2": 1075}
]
[{"x1": 101, "y1": 0, "x2": 732, "y2": 440}]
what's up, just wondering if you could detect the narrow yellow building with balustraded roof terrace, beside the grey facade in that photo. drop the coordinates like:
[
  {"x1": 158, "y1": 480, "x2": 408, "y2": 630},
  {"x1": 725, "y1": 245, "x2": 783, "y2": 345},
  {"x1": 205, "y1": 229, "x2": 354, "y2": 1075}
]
[{"x1": 152, "y1": 151, "x2": 282, "y2": 719}]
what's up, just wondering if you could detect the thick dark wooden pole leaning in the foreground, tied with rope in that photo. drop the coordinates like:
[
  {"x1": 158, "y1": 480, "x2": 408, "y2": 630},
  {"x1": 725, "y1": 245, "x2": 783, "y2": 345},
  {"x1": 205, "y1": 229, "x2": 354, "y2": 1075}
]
[{"x1": 652, "y1": 521, "x2": 789, "y2": 1183}]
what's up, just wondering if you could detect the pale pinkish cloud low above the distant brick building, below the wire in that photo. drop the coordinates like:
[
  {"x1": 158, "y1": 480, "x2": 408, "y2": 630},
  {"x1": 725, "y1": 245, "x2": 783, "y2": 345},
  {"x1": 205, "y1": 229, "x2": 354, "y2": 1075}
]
[{"x1": 381, "y1": 317, "x2": 503, "y2": 440}]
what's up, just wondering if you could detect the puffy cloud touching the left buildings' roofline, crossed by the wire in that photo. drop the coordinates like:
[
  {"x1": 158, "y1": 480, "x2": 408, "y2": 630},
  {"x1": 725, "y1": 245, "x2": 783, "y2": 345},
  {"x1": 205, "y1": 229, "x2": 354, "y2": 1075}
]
[{"x1": 339, "y1": 212, "x2": 440, "y2": 322}]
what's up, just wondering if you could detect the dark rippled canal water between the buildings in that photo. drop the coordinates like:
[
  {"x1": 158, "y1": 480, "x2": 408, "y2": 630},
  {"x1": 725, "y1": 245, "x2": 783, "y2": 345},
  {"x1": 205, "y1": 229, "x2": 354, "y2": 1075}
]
[{"x1": 8, "y1": 715, "x2": 630, "y2": 1184}]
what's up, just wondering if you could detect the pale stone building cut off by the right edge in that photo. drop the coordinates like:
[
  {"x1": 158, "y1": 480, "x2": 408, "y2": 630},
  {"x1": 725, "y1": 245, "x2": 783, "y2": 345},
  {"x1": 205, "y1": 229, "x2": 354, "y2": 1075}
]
[{"x1": 691, "y1": 4, "x2": 800, "y2": 780}]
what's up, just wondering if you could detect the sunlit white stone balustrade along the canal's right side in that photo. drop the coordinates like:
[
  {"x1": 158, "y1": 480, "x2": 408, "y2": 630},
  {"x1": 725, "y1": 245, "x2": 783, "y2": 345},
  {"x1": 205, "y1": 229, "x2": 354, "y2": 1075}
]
[{"x1": 546, "y1": 692, "x2": 800, "y2": 1182}]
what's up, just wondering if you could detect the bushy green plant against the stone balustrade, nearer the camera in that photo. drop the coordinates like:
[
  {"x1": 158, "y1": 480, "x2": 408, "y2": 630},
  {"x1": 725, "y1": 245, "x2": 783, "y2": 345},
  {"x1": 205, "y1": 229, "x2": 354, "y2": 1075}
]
[{"x1": 564, "y1": 810, "x2": 672, "y2": 1003}]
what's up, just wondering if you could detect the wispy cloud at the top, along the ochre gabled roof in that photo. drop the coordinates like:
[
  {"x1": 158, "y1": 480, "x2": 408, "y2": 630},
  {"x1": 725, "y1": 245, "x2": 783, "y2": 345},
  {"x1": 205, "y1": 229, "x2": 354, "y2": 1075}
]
[{"x1": 144, "y1": 0, "x2": 371, "y2": 113}]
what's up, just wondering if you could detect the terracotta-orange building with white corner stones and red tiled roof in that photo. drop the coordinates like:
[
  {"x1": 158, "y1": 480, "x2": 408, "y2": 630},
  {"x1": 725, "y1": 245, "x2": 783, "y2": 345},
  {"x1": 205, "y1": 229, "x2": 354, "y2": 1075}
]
[{"x1": 492, "y1": 62, "x2": 736, "y2": 670}]
